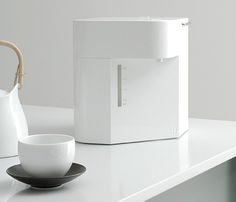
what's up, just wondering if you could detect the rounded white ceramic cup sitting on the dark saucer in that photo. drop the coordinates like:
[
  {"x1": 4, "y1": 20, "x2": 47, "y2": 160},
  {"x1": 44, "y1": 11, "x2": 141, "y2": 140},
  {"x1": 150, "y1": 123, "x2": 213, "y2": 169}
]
[{"x1": 18, "y1": 134, "x2": 75, "y2": 178}]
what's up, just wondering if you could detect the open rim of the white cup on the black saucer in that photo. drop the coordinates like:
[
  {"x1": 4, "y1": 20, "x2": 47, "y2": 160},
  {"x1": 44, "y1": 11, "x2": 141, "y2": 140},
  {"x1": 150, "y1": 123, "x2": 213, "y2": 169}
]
[{"x1": 18, "y1": 134, "x2": 75, "y2": 146}]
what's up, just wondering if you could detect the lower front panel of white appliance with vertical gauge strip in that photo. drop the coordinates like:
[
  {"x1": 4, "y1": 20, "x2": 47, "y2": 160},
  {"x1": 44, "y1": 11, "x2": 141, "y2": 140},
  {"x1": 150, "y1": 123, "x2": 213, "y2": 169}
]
[{"x1": 110, "y1": 57, "x2": 179, "y2": 142}]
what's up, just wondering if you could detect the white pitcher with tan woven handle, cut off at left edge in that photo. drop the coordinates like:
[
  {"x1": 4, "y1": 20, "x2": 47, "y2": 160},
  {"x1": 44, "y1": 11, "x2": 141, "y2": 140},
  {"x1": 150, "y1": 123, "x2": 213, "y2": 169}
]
[{"x1": 0, "y1": 40, "x2": 28, "y2": 158}]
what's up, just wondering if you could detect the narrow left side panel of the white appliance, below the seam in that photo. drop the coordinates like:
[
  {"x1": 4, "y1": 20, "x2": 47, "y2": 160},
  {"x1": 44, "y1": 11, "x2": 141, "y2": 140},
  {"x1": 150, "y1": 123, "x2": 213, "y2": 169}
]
[{"x1": 74, "y1": 58, "x2": 111, "y2": 144}]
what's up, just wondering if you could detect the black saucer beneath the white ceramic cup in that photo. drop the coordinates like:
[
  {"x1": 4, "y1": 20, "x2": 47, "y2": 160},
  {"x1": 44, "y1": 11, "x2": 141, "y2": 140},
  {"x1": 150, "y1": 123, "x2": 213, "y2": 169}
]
[{"x1": 7, "y1": 163, "x2": 86, "y2": 189}]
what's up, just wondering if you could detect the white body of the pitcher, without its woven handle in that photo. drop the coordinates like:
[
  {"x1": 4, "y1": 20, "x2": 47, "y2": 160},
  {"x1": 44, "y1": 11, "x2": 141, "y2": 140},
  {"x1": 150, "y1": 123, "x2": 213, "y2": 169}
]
[{"x1": 0, "y1": 84, "x2": 28, "y2": 158}]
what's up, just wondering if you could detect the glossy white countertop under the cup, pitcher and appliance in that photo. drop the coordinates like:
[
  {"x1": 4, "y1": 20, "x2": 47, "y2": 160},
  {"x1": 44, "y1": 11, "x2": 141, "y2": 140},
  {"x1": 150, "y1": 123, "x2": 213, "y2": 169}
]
[{"x1": 0, "y1": 106, "x2": 236, "y2": 202}]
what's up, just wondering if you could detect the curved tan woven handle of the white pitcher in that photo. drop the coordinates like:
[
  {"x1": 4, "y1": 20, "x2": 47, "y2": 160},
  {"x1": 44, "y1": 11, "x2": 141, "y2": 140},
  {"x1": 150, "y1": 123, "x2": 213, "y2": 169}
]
[{"x1": 0, "y1": 40, "x2": 24, "y2": 89}]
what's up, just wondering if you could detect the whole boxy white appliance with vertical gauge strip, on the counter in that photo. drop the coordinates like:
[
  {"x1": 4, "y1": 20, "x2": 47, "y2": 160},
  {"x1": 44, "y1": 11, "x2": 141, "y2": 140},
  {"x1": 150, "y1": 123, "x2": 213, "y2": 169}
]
[{"x1": 74, "y1": 17, "x2": 189, "y2": 144}]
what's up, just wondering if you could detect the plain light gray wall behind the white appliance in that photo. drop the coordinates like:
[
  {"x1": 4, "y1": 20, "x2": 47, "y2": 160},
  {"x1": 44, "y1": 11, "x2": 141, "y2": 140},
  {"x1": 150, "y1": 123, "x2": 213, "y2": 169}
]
[{"x1": 0, "y1": 0, "x2": 236, "y2": 120}]
